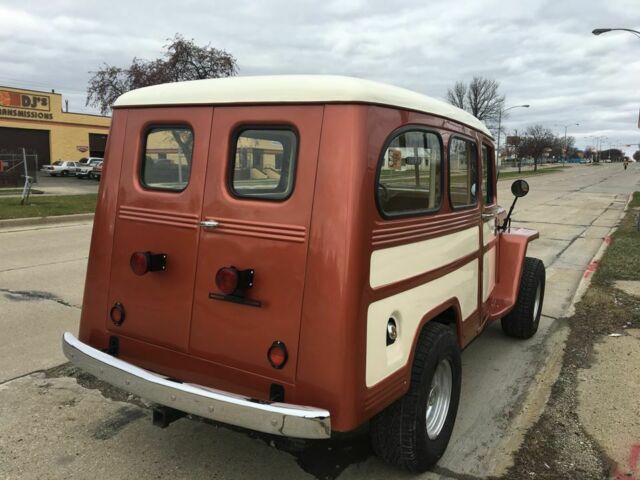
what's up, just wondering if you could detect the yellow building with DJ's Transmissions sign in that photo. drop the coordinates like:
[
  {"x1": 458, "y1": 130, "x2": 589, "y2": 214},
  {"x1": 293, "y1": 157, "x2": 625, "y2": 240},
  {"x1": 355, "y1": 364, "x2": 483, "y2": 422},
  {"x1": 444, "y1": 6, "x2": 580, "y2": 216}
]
[{"x1": 0, "y1": 87, "x2": 111, "y2": 165}]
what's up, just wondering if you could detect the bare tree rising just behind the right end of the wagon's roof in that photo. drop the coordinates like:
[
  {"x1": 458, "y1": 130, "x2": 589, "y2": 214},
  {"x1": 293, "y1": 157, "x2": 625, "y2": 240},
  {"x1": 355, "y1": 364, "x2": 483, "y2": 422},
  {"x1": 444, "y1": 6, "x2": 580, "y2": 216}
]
[{"x1": 447, "y1": 77, "x2": 505, "y2": 122}]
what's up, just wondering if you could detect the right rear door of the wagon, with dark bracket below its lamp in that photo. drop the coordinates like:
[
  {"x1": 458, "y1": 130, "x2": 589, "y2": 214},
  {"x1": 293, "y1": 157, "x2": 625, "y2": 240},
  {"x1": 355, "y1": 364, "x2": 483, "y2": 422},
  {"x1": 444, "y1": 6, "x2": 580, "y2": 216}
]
[{"x1": 189, "y1": 105, "x2": 322, "y2": 382}]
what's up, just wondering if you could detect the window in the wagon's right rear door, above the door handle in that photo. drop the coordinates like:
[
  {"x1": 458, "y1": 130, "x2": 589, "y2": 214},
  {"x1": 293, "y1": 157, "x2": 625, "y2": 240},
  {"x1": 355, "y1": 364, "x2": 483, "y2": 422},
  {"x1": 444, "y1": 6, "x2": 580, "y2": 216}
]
[{"x1": 230, "y1": 128, "x2": 298, "y2": 200}]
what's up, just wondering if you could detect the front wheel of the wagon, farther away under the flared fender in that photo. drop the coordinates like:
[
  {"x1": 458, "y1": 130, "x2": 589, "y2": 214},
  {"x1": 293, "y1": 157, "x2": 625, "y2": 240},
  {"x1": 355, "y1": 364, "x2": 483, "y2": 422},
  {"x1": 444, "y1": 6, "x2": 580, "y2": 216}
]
[{"x1": 501, "y1": 257, "x2": 546, "y2": 339}]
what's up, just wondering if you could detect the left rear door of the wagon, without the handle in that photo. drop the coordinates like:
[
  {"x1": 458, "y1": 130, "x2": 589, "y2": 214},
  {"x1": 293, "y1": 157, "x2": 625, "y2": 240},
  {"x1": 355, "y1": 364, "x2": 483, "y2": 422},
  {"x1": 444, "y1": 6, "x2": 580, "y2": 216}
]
[{"x1": 105, "y1": 107, "x2": 213, "y2": 352}]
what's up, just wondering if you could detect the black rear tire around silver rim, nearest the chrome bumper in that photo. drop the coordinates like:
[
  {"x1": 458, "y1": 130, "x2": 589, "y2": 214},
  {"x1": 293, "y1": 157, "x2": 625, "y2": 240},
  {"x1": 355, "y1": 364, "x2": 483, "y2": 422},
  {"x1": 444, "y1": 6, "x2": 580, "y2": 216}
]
[{"x1": 370, "y1": 321, "x2": 462, "y2": 472}]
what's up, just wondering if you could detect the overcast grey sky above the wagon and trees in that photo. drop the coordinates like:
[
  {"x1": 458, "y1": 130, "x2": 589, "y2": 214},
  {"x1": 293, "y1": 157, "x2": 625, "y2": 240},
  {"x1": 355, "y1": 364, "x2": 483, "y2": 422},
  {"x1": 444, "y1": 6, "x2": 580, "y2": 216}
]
[{"x1": 0, "y1": 0, "x2": 640, "y2": 152}]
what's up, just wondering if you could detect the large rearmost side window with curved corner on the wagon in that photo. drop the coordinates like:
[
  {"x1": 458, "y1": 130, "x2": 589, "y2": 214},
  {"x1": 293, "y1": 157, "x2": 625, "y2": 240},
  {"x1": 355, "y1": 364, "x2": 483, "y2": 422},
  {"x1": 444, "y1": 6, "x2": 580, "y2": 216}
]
[{"x1": 376, "y1": 130, "x2": 442, "y2": 216}]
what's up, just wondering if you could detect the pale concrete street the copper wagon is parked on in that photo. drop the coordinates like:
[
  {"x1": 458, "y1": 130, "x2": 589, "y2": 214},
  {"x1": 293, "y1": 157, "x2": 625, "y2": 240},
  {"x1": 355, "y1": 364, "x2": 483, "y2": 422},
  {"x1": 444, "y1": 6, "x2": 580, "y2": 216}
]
[{"x1": 0, "y1": 164, "x2": 640, "y2": 479}]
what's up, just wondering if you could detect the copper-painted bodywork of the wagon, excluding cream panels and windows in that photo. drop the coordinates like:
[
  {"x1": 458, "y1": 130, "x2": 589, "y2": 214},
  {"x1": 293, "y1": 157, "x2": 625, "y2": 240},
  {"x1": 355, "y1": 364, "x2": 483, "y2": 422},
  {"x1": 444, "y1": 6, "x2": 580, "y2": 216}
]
[{"x1": 80, "y1": 99, "x2": 532, "y2": 431}]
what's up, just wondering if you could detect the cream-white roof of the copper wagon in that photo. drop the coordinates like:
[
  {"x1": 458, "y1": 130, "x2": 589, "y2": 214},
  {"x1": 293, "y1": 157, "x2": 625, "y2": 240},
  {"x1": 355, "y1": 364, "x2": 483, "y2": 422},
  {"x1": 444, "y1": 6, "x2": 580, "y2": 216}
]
[{"x1": 113, "y1": 75, "x2": 492, "y2": 137}]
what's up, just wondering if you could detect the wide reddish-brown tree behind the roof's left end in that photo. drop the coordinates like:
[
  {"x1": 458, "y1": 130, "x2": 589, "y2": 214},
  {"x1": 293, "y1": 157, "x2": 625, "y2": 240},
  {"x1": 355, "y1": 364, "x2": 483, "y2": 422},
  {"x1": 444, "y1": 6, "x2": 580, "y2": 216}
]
[{"x1": 86, "y1": 34, "x2": 238, "y2": 114}]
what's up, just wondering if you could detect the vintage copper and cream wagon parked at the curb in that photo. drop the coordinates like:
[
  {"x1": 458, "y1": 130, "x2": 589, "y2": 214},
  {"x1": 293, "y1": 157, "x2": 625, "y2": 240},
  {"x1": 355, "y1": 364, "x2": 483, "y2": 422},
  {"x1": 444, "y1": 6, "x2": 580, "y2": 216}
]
[{"x1": 63, "y1": 76, "x2": 545, "y2": 471}]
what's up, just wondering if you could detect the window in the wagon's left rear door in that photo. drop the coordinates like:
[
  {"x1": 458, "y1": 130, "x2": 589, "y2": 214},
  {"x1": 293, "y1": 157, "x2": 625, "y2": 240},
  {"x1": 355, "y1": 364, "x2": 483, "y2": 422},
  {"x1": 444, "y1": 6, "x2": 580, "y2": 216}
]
[{"x1": 140, "y1": 127, "x2": 193, "y2": 192}]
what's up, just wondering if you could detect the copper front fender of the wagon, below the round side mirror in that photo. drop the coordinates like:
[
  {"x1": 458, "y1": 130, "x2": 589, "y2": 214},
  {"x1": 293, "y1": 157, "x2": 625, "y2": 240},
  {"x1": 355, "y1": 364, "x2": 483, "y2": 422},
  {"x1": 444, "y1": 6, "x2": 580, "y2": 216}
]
[{"x1": 488, "y1": 228, "x2": 540, "y2": 320}]
